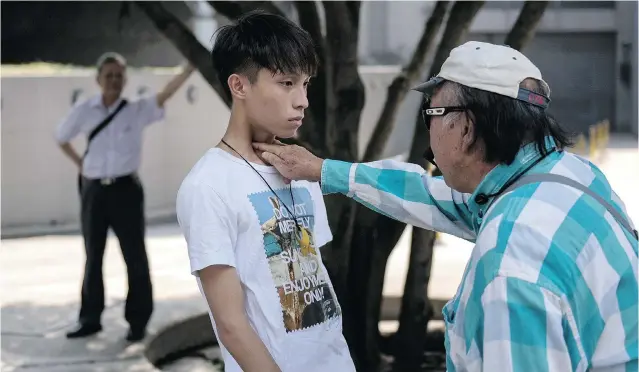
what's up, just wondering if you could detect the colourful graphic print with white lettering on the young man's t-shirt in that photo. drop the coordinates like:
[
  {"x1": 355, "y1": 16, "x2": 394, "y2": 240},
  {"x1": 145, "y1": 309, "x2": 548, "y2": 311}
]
[{"x1": 249, "y1": 188, "x2": 341, "y2": 332}]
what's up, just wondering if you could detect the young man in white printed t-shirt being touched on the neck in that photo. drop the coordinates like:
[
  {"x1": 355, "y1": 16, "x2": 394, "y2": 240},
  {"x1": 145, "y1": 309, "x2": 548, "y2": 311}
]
[{"x1": 177, "y1": 13, "x2": 355, "y2": 372}]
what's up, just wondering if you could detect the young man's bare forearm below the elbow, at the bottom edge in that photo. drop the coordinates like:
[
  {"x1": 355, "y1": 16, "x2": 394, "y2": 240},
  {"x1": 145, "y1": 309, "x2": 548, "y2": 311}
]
[{"x1": 217, "y1": 320, "x2": 280, "y2": 372}]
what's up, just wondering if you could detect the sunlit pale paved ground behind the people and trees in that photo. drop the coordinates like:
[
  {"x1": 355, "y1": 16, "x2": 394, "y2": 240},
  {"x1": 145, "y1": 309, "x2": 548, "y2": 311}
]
[{"x1": 0, "y1": 137, "x2": 639, "y2": 372}]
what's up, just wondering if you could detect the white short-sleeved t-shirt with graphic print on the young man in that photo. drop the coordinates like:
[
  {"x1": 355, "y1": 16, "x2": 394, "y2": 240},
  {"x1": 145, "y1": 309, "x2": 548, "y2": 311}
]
[{"x1": 176, "y1": 148, "x2": 355, "y2": 372}]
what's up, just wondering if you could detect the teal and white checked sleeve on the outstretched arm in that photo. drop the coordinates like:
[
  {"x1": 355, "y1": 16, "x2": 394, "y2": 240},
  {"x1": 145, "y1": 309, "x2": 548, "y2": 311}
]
[{"x1": 321, "y1": 160, "x2": 475, "y2": 240}]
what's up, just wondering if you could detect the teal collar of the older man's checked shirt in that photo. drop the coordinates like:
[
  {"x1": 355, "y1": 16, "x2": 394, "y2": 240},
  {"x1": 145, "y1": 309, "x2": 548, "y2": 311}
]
[{"x1": 468, "y1": 136, "x2": 556, "y2": 218}]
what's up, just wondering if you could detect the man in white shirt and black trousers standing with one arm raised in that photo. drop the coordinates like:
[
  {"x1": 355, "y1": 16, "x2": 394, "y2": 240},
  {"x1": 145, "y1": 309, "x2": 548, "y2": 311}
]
[{"x1": 55, "y1": 53, "x2": 194, "y2": 341}]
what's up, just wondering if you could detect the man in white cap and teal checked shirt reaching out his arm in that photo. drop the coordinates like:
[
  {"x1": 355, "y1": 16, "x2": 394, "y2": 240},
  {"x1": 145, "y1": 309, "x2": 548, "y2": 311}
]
[{"x1": 254, "y1": 42, "x2": 639, "y2": 372}]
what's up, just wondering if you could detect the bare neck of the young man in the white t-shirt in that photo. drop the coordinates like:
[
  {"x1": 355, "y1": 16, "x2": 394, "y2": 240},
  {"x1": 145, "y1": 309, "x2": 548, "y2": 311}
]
[{"x1": 218, "y1": 109, "x2": 275, "y2": 164}]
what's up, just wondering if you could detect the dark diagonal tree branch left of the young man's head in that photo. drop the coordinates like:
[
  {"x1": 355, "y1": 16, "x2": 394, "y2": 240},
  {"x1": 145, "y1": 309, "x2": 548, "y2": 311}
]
[{"x1": 135, "y1": 1, "x2": 231, "y2": 107}]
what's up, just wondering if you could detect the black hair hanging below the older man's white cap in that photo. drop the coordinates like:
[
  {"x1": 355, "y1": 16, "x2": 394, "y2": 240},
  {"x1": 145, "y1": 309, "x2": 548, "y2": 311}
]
[{"x1": 453, "y1": 79, "x2": 572, "y2": 165}]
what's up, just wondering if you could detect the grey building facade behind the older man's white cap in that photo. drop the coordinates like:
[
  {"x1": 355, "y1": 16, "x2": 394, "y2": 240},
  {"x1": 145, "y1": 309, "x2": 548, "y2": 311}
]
[{"x1": 360, "y1": 1, "x2": 639, "y2": 135}]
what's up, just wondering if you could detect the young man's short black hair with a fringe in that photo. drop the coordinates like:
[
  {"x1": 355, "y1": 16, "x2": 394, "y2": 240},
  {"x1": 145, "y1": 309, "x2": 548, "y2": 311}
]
[{"x1": 211, "y1": 10, "x2": 319, "y2": 98}]
